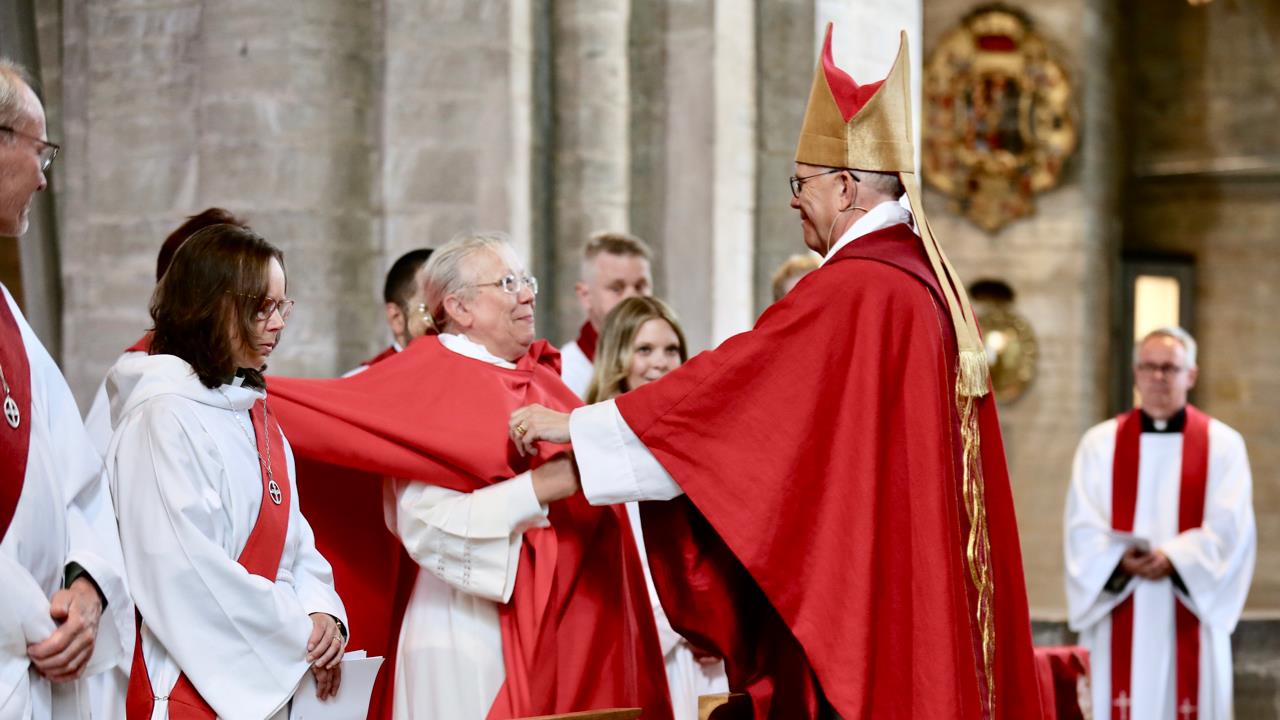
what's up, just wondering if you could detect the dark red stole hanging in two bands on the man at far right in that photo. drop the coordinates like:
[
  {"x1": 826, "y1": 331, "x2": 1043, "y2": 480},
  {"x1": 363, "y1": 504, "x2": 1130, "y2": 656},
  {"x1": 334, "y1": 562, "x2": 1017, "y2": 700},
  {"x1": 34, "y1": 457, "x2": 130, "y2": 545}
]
[{"x1": 1111, "y1": 405, "x2": 1208, "y2": 720}]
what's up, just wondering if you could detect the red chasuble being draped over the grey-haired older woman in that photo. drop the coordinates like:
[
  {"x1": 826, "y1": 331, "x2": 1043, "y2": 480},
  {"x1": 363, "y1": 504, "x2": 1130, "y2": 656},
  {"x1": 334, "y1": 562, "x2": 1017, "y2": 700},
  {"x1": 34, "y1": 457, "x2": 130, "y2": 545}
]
[{"x1": 270, "y1": 337, "x2": 671, "y2": 720}]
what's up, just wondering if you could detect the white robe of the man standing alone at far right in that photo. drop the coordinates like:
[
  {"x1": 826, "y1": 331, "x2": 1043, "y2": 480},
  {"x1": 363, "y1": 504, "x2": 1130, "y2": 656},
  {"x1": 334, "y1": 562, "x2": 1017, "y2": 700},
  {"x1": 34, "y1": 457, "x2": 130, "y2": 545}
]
[{"x1": 1064, "y1": 419, "x2": 1257, "y2": 720}]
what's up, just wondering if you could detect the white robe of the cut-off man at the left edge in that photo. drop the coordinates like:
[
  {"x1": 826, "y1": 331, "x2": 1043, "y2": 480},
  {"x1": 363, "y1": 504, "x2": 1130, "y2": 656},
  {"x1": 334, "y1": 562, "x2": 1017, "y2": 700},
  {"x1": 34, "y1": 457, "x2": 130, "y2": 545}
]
[{"x1": 0, "y1": 286, "x2": 132, "y2": 720}]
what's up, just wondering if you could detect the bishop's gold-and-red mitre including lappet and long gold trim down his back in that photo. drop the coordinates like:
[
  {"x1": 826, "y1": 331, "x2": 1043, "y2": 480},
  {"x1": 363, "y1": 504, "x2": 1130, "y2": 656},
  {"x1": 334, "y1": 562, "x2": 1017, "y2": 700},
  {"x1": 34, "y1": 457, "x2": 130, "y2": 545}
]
[{"x1": 796, "y1": 23, "x2": 1018, "y2": 714}]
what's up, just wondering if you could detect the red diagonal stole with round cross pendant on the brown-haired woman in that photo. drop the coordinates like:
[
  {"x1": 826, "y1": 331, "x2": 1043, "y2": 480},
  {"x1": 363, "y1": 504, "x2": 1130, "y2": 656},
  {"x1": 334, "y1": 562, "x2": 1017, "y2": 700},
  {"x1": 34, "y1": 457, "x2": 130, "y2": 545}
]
[{"x1": 125, "y1": 400, "x2": 291, "y2": 720}]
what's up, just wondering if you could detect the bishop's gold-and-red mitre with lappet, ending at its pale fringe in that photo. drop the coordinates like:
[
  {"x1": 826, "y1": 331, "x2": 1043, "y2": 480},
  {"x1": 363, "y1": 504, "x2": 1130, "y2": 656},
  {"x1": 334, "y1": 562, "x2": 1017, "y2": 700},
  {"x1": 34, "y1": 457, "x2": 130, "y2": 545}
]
[{"x1": 796, "y1": 23, "x2": 988, "y2": 397}]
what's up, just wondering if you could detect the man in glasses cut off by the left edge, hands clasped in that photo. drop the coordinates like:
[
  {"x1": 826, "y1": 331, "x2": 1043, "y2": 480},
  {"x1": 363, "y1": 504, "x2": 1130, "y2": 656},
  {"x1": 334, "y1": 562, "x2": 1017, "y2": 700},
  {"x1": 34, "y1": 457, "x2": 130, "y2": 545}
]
[{"x1": 0, "y1": 58, "x2": 133, "y2": 719}]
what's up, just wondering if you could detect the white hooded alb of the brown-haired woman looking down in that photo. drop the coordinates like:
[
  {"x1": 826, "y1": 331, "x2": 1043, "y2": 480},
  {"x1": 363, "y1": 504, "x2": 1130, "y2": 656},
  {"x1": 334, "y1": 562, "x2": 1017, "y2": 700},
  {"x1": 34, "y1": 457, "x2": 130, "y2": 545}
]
[{"x1": 106, "y1": 355, "x2": 347, "y2": 719}]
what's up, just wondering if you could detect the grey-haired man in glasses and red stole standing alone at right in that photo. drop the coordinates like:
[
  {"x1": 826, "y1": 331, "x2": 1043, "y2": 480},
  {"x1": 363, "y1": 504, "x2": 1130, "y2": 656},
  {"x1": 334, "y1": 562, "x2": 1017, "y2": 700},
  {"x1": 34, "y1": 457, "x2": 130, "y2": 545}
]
[{"x1": 1064, "y1": 327, "x2": 1257, "y2": 720}]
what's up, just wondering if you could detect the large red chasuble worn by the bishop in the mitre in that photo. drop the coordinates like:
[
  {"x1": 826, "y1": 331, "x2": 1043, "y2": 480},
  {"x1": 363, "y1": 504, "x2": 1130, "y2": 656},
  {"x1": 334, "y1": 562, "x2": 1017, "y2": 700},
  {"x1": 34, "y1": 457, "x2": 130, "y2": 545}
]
[{"x1": 617, "y1": 224, "x2": 1041, "y2": 720}]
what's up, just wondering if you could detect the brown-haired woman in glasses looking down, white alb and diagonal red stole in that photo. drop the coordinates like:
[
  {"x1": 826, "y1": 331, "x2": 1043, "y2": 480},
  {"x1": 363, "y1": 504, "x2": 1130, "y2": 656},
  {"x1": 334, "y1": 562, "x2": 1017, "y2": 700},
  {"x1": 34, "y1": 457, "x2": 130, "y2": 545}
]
[{"x1": 106, "y1": 224, "x2": 346, "y2": 720}]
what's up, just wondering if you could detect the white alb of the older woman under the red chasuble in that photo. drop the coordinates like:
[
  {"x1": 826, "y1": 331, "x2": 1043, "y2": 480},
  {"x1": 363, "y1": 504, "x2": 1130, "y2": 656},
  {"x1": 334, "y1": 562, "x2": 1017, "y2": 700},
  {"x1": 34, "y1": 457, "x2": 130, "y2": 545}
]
[{"x1": 387, "y1": 333, "x2": 549, "y2": 720}]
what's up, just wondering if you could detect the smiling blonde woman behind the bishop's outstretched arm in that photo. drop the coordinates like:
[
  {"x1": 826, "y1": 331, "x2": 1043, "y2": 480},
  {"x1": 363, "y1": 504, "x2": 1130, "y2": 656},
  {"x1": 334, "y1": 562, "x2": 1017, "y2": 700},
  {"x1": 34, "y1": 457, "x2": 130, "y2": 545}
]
[{"x1": 586, "y1": 297, "x2": 728, "y2": 720}]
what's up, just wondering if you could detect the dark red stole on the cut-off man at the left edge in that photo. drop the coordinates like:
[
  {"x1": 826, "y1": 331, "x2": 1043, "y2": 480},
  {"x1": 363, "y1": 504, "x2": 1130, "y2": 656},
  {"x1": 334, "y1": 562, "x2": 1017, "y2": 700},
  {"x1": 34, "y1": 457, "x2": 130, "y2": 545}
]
[{"x1": 0, "y1": 297, "x2": 31, "y2": 541}]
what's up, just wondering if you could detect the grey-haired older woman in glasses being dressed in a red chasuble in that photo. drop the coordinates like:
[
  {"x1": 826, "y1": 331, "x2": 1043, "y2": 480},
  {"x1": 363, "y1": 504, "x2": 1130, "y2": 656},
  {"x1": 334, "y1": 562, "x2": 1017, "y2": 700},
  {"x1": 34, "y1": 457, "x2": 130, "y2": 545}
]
[{"x1": 273, "y1": 234, "x2": 671, "y2": 720}]
